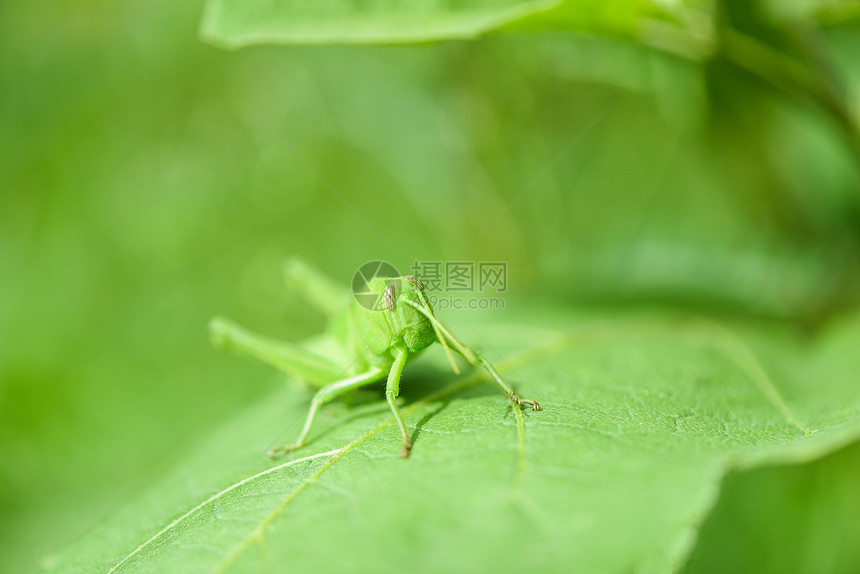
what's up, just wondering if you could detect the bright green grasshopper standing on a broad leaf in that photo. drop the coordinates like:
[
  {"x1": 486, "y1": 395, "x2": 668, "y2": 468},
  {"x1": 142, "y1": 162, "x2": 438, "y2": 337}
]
[{"x1": 209, "y1": 260, "x2": 541, "y2": 458}]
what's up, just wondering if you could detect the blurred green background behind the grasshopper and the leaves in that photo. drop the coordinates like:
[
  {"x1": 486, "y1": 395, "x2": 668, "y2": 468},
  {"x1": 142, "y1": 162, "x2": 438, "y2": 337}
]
[{"x1": 0, "y1": 2, "x2": 860, "y2": 572}]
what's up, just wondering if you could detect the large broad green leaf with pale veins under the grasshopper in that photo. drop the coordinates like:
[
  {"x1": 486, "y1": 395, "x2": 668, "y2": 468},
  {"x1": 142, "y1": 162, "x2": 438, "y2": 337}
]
[{"x1": 45, "y1": 307, "x2": 860, "y2": 572}]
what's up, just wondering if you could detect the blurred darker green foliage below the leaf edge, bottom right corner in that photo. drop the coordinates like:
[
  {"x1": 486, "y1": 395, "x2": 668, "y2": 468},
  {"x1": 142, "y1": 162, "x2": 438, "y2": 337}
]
[{"x1": 681, "y1": 442, "x2": 860, "y2": 574}]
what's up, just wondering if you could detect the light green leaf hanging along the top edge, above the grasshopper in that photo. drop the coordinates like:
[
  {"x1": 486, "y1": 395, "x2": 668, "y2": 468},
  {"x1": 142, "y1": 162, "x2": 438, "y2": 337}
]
[{"x1": 201, "y1": 0, "x2": 681, "y2": 48}]
